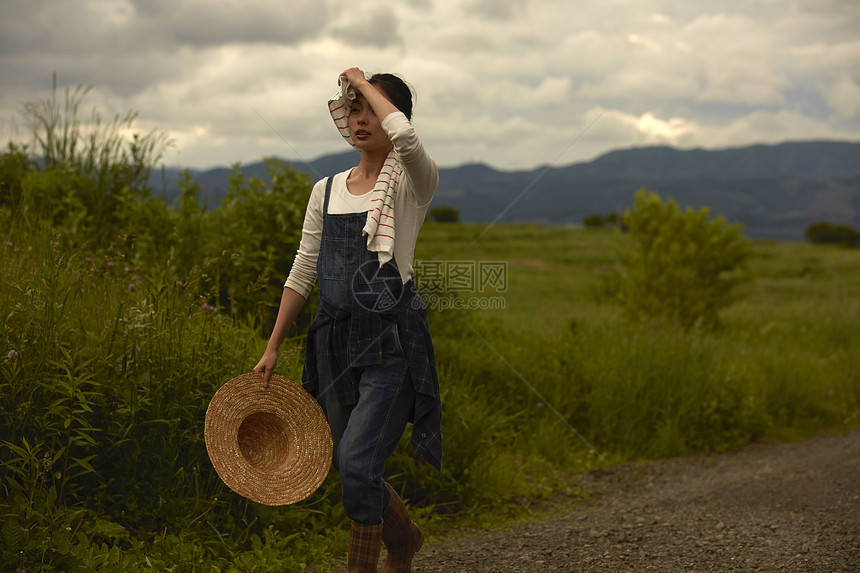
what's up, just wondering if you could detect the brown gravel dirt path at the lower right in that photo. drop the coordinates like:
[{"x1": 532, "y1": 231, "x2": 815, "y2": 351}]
[{"x1": 413, "y1": 431, "x2": 860, "y2": 573}]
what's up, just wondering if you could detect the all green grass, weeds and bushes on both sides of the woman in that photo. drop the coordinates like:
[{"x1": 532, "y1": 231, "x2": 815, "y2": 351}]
[{"x1": 0, "y1": 82, "x2": 860, "y2": 572}]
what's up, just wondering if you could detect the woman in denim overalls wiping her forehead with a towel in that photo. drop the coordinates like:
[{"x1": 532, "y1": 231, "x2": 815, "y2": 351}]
[{"x1": 254, "y1": 68, "x2": 442, "y2": 573}]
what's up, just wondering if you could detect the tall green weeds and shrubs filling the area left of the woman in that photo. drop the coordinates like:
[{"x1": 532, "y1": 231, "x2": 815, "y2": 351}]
[{"x1": 0, "y1": 77, "x2": 326, "y2": 571}]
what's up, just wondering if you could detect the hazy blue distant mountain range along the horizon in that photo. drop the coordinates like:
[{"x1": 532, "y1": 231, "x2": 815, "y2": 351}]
[{"x1": 152, "y1": 141, "x2": 860, "y2": 240}]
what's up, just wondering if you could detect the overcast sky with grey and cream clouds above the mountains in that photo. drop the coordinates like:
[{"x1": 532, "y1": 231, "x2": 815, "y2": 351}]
[{"x1": 0, "y1": 0, "x2": 860, "y2": 169}]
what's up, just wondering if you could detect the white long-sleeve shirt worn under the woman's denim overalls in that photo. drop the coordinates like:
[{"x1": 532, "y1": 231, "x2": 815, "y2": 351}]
[{"x1": 284, "y1": 111, "x2": 439, "y2": 298}]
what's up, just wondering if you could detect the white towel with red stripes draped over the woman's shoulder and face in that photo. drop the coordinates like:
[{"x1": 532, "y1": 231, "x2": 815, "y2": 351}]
[{"x1": 328, "y1": 77, "x2": 403, "y2": 267}]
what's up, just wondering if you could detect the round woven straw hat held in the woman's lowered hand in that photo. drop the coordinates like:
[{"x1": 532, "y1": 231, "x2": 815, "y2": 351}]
[{"x1": 204, "y1": 372, "x2": 333, "y2": 505}]
